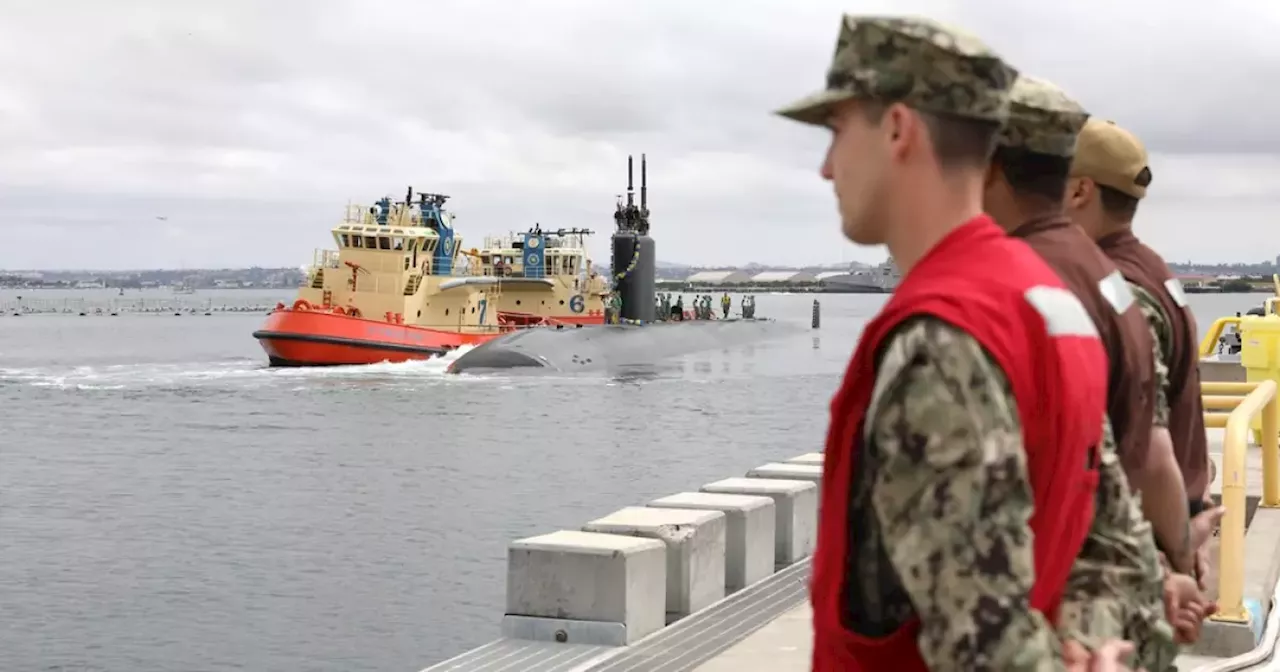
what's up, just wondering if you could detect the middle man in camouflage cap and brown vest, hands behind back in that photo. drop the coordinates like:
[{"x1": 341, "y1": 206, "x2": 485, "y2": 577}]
[{"x1": 984, "y1": 76, "x2": 1210, "y2": 672}]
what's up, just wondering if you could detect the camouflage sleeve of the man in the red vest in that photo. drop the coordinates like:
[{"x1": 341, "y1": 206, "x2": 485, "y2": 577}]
[{"x1": 844, "y1": 317, "x2": 1061, "y2": 671}]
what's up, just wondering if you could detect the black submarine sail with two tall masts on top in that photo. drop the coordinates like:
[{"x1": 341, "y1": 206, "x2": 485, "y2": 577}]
[{"x1": 613, "y1": 154, "x2": 657, "y2": 323}]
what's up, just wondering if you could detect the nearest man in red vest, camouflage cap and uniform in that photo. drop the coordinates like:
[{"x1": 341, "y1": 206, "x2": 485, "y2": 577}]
[{"x1": 780, "y1": 15, "x2": 1129, "y2": 672}]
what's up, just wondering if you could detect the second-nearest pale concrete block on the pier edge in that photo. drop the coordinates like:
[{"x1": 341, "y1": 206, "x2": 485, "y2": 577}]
[{"x1": 582, "y1": 507, "x2": 726, "y2": 618}]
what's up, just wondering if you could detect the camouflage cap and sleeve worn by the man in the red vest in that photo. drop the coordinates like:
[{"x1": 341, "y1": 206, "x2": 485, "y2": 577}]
[{"x1": 778, "y1": 15, "x2": 1119, "y2": 671}]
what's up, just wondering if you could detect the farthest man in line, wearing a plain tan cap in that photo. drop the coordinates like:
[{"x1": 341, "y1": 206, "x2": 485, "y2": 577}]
[{"x1": 1066, "y1": 119, "x2": 1225, "y2": 589}]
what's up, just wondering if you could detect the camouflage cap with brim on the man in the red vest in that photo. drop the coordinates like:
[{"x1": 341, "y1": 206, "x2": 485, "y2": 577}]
[{"x1": 778, "y1": 14, "x2": 1018, "y2": 125}]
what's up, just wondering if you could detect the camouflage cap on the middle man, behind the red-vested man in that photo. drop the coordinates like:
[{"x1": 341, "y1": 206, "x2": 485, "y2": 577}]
[{"x1": 1000, "y1": 74, "x2": 1089, "y2": 157}]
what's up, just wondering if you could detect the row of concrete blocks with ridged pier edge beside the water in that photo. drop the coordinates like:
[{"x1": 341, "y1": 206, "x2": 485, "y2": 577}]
[{"x1": 428, "y1": 453, "x2": 822, "y2": 672}]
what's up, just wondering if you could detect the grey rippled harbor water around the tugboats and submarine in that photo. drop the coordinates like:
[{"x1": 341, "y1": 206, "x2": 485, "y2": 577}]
[{"x1": 0, "y1": 291, "x2": 1265, "y2": 672}]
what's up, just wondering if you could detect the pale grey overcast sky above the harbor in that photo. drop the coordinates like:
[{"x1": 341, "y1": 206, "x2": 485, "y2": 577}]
[{"x1": 0, "y1": 0, "x2": 1280, "y2": 269}]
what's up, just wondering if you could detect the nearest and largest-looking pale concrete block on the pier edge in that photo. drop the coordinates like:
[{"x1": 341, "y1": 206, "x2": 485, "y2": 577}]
[{"x1": 507, "y1": 530, "x2": 667, "y2": 644}]
